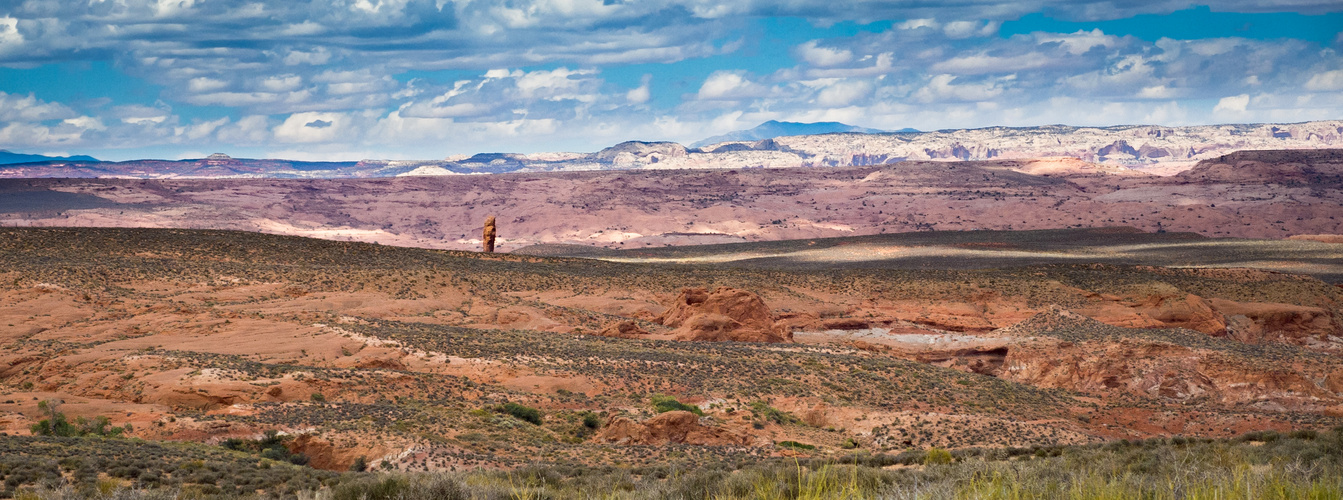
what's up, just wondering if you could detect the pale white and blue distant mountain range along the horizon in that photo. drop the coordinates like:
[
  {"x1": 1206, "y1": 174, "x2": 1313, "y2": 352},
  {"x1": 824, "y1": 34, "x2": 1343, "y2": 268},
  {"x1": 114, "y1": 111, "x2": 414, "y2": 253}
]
[{"x1": 0, "y1": 120, "x2": 1343, "y2": 179}]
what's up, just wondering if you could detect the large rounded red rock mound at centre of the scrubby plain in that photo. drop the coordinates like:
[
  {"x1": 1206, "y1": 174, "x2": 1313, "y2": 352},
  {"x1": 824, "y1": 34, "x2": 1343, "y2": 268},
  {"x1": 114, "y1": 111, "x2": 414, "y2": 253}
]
[{"x1": 657, "y1": 286, "x2": 792, "y2": 343}]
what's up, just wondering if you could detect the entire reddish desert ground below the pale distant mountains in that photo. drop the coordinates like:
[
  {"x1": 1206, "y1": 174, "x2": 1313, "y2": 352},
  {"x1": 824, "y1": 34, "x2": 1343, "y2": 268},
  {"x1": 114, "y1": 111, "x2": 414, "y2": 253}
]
[{"x1": 0, "y1": 152, "x2": 1343, "y2": 499}]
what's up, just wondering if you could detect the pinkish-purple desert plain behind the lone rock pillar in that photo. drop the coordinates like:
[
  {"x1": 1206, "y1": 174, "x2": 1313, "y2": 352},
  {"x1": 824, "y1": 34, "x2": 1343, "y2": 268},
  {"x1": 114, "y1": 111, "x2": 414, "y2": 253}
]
[{"x1": 0, "y1": 148, "x2": 1343, "y2": 251}]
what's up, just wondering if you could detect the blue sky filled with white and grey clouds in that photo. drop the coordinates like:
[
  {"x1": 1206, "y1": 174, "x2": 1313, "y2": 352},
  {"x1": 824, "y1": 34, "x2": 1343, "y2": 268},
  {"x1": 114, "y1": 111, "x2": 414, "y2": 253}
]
[{"x1": 0, "y1": 0, "x2": 1343, "y2": 160}]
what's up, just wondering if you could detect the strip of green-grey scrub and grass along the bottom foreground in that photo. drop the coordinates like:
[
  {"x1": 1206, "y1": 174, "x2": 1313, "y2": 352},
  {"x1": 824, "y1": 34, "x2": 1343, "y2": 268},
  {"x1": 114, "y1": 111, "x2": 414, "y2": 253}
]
[{"x1": 10, "y1": 431, "x2": 1343, "y2": 500}]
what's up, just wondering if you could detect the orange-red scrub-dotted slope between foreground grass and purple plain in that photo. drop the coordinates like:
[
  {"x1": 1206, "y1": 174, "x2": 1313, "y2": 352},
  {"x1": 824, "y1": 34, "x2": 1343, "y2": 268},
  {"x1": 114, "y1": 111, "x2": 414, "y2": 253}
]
[{"x1": 0, "y1": 228, "x2": 1343, "y2": 470}]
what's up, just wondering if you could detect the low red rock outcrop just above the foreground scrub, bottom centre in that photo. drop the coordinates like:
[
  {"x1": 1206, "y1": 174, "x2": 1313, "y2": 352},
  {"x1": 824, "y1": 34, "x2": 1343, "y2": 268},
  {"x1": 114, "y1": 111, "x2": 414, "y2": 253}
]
[{"x1": 596, "y1": 411, "x2": 751, "y2": 446}]
